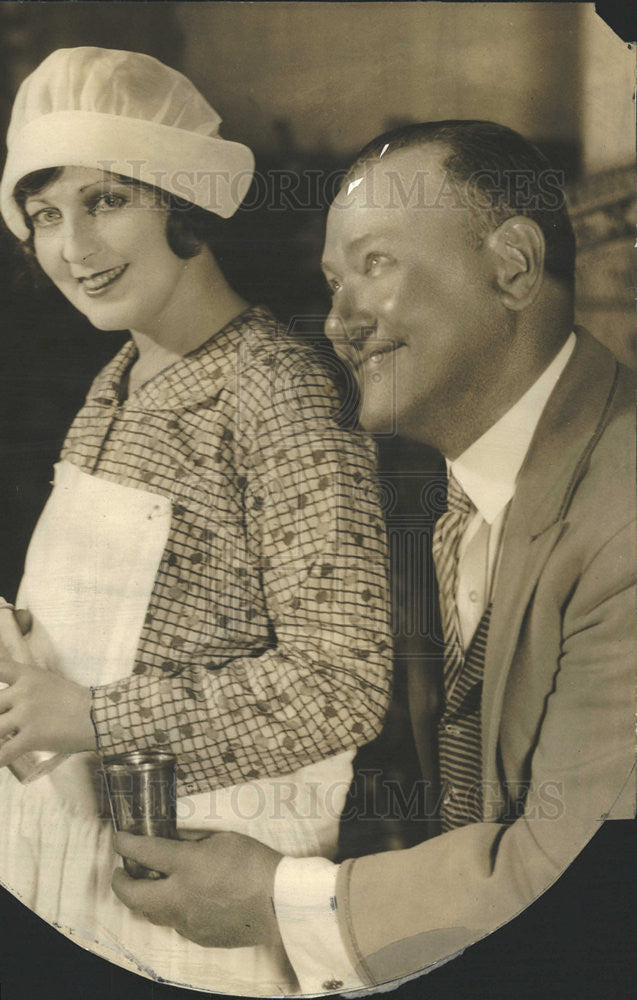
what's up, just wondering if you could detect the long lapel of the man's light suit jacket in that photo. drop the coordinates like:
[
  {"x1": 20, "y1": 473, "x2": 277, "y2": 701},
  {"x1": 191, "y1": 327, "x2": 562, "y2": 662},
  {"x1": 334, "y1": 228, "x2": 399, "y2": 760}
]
[{"x1": 482, "y1": 330, "x2": 617, "y2": 804}]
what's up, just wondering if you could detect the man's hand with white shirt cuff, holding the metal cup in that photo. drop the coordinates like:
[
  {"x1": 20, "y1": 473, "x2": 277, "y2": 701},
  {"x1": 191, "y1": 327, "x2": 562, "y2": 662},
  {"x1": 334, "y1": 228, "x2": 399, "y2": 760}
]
[{"x1": 113, "y1": 833, "x2": 362, "y2": 993}]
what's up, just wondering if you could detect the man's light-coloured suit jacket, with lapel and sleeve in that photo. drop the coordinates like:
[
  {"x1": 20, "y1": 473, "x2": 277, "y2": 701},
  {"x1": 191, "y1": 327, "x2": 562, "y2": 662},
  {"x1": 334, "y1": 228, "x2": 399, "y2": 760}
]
[{"x1": 337, "y1": 331, "x2": 635, "y2": 985}]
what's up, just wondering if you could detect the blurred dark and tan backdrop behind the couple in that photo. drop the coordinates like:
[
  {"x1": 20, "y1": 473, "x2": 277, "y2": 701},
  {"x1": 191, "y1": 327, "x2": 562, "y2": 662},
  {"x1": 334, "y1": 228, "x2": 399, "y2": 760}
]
[{"x1": 0, "y1": 2, "x2": 637, "y2": 854}]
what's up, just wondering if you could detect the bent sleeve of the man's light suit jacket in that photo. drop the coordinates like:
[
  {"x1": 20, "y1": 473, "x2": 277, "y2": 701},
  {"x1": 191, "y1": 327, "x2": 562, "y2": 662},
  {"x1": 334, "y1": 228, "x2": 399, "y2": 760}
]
[{"x1": 336, "y1": 524, "x2": 635, "y2": 984}]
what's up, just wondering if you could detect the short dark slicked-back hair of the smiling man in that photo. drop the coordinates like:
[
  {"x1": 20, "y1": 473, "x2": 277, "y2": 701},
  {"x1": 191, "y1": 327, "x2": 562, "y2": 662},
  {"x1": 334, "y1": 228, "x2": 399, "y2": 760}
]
[{"x1": 343, "y1": 119, "x2": 575, "y2": 287}]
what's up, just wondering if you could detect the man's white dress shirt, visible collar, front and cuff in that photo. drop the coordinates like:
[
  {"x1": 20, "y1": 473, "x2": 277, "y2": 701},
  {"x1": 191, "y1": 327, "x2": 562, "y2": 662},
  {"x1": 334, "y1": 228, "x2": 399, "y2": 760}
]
[{"x1": 274, "y1": 333, "x2": 576, "y2": 993}]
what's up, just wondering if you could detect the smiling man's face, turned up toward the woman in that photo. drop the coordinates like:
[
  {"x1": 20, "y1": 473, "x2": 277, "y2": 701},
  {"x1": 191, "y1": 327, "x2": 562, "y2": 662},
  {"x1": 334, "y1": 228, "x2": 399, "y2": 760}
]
[{"x1": 323, "y1": 147, "x2": 506, "y2": 443}]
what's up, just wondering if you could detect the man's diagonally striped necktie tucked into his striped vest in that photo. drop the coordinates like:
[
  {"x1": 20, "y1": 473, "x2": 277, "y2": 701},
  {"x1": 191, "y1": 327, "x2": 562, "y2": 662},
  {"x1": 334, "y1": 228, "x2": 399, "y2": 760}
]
[{"x1": 432, "y1": 474, "x2": 476, "y2": 692}]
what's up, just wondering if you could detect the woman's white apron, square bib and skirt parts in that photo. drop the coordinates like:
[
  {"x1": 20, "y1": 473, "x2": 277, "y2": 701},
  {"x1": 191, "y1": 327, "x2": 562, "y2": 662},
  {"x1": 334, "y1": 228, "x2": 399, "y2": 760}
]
[{"x1": 0, "y1": 461, "x2": 353, "y2": 995}]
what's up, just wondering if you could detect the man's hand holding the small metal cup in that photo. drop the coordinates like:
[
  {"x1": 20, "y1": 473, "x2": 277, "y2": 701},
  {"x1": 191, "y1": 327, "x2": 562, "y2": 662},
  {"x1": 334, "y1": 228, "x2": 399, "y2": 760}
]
[{"x1": 112, "y1": 833, "x2": 281, "y2": 948}]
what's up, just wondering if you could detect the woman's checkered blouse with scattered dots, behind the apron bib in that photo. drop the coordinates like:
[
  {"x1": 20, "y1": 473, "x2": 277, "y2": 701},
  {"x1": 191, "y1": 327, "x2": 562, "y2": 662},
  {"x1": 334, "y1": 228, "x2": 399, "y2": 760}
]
[{"x1": 62, "y1": 307, "x2": 392, "y2": 792}]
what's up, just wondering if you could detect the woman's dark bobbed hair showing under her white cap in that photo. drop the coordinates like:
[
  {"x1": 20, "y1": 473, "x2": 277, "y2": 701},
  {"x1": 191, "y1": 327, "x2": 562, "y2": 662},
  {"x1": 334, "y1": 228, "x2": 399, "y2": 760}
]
[{"x1": 13, "y1": 167, "x2": 223, "y2": 260}]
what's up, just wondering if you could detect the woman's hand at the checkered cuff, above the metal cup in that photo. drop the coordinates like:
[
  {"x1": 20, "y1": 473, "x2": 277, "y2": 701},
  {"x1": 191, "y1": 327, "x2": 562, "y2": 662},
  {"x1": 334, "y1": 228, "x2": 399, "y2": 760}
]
[{"x1": 0, "y1": 659, "x2": 96, "y2": 767}]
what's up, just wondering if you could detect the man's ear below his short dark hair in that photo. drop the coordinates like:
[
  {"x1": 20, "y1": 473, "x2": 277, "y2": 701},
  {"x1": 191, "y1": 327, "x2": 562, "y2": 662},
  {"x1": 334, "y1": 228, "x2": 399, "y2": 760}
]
[{"x1": 487, "y1": 215, "x2": 545, "y2": 312}]
